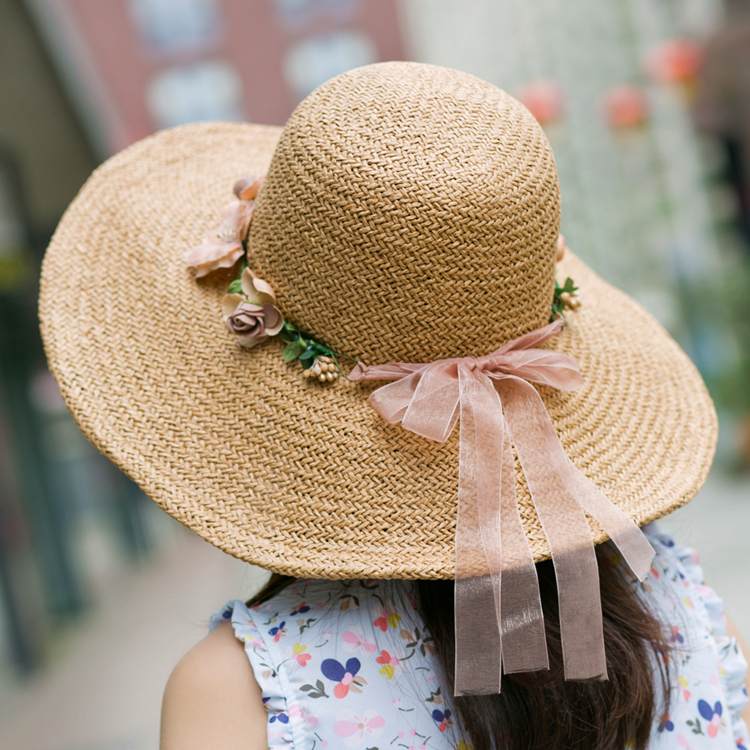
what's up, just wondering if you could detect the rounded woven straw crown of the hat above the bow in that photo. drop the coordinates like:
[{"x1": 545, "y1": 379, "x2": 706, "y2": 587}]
[{"x1": 249, "y1": 63, "x2": 560, "y2": 364}]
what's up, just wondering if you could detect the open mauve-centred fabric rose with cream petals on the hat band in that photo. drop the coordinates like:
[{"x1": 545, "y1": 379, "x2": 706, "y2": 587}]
[{"x1": 223, "y1": 268, "x2": 284, "y2": 348}]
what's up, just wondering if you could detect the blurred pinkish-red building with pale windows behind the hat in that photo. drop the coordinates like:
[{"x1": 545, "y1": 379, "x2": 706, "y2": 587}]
[{"x1": 27, "y1": 0, "x2": 403, "y2": 153}]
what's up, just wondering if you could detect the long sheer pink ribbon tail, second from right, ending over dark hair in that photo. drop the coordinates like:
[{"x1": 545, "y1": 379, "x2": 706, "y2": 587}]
[{"x1": 495, "y1": 377, "x2": 607, "y2": 680}]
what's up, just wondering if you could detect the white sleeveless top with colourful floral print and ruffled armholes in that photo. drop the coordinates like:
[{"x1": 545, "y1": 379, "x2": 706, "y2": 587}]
[{"x1": 211, "y1": 524, "x2": 748, "y2": 750}]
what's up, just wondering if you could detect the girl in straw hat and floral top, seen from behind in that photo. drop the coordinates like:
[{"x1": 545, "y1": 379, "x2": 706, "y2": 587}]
[{"x1": 40, "y1": 63, "x2": 747, "y2": 750}]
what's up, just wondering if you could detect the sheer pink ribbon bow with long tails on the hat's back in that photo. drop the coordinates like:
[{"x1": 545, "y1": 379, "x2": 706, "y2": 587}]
[{"x1": 349, "y1": 320, "x2": 654, "y2": 695}]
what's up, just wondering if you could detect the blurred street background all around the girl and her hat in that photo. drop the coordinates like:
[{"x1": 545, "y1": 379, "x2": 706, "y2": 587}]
[{"x1": 0, "y1": 0, "x2": 750, "y2": 750}]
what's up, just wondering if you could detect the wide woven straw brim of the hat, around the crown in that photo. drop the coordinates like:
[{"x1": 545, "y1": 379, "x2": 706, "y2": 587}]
[{"x1": 40, "y1": 123, "x2": 717, "y2": 578}]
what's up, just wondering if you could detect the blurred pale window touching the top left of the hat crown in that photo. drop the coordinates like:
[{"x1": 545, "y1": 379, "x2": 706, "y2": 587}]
[{"x1": 284, "y1": 31, "x2": 377, "y2": 99}]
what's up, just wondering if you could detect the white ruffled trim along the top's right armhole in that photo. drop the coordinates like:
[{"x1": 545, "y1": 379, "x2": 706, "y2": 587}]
[{"x1": 647, "y1": 524, "x2": 750, "y2": 750}]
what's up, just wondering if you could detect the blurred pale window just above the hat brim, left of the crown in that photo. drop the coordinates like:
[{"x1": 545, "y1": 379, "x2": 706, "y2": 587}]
[{"x1": 147, "y1": 60, "x2": 245, "y2": 128}]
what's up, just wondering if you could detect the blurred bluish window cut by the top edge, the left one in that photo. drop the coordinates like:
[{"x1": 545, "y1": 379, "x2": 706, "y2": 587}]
[{"x1": 129, "y1": 0, "x2": 219, "y2": 54}]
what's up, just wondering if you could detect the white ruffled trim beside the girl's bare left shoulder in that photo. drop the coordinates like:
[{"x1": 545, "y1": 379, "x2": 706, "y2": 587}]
[{"x1": 209, "y1": 599, "x2": 297, "y2": 750}]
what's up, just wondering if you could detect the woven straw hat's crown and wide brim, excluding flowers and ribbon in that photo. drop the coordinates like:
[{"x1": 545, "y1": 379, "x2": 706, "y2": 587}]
[{"x1": 40, "y1": 63, "x2": 717, "y2": 578}]
